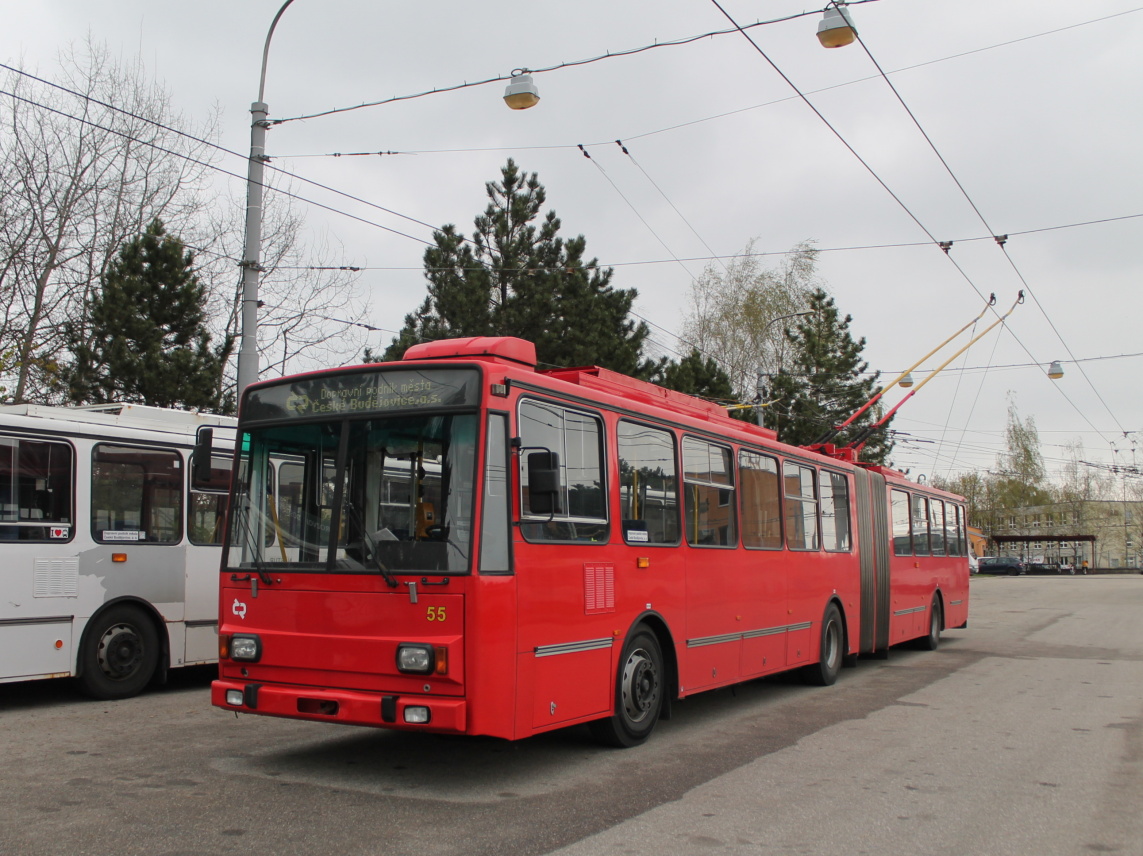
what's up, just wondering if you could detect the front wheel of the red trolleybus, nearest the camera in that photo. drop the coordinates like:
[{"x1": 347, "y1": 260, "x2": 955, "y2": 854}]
[{"x1": 591, "y1": 625, "x2": 666, "y2": 749}]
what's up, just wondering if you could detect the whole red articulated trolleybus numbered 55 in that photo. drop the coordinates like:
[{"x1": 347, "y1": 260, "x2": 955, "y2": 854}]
[{"x1": 211, "y1": 338, "x2": 968, "y2": 746}]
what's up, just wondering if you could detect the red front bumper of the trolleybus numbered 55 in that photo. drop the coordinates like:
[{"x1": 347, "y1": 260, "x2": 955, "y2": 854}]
[{"x1": 210, "y1": 679, "x2": 466, "y2": 734}]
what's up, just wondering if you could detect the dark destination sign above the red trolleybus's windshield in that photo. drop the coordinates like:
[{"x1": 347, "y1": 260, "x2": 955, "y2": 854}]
[{"x1": 241, "y1": 369, "x2": 480, "y2": 422}]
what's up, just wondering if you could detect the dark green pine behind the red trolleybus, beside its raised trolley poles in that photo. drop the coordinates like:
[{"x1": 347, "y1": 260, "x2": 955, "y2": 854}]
[{"x1": 762, "y1": 289, "x2": 893, "y2": 464}]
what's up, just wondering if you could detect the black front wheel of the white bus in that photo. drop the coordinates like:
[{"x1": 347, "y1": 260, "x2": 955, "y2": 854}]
[{"x1": 79, "y1": 605, "x2": 159, "y2": 699}]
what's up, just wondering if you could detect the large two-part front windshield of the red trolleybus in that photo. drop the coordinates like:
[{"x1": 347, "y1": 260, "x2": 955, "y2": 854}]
[{"x1": 226, "y1": 414, "x2": 477, "y2": 575}]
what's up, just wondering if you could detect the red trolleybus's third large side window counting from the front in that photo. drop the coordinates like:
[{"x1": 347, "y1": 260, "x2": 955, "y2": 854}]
[{"x1": 682, "y1": 437, "x2": 737, "y2": 547}]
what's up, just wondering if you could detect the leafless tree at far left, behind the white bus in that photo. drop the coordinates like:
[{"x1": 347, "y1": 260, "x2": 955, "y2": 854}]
[{"x1": 0, "y1": 40, "x2": 216, "y2": 401}]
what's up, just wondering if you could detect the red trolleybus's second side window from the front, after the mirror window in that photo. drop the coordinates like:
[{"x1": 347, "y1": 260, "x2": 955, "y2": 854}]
[{"x1": 617, "y1": 422, "x2": 679, "y2": 544}]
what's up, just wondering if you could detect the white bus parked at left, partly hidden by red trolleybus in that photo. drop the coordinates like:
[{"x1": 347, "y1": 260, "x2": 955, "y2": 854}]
[{"x1": 0, "y1": 405, "x2": 235, "y2": 698}]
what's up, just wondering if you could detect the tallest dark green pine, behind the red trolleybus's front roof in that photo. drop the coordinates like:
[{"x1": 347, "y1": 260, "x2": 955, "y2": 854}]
[{"x1": 384, "y1": 160, "x2": 656, "y2": 377}]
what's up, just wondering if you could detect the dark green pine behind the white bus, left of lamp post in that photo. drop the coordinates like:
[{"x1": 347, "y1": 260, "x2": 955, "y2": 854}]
[{"x1": 63, "y1": 219, "x2": 234, "y2": 410}]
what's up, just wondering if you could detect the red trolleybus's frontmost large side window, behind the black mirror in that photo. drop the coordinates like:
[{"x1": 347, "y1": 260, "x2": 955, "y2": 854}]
[{"x1": 519, "y1": 401, "x2": 608, "y2": 544}]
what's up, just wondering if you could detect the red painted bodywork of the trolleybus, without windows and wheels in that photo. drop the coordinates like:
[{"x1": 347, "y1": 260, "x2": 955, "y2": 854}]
[{"x1": 211, "y1": 339, "x2": 968, "y2": 739}]
